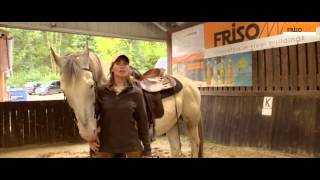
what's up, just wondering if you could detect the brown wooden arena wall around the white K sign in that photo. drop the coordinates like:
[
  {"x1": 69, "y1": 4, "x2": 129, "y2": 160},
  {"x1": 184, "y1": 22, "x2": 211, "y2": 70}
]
[{"x1": 200, "y1": 42, "x2": 320, "y2": 155}]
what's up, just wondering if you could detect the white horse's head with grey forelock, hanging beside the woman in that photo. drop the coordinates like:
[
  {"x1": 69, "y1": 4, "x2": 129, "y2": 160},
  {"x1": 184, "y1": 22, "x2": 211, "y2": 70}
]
[{"x1": 51, "y1": 48, "x2": 101, "y2": 141}]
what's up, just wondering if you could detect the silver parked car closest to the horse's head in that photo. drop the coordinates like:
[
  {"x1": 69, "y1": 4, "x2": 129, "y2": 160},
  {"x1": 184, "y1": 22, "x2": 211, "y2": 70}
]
[{"x1": 35, "y1": 80, "x2": 62, "y2": 95}]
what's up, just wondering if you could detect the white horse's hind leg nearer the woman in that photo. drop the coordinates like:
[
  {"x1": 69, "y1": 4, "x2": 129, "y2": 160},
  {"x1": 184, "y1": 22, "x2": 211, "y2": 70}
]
[{"x1": 166, "y1": 124, "x2": 182, "y2": 157}]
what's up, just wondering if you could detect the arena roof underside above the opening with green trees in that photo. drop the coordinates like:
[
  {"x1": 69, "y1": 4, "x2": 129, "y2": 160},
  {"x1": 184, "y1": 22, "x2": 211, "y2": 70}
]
[{"x1": 0, "y1": 22, "x2": 200, "y2": 41}]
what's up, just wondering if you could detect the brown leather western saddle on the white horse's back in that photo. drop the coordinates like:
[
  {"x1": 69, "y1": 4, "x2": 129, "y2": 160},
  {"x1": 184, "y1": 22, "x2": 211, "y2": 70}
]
[{"x1": 134, "y1": 68, "x2": 182, "y2": 139}]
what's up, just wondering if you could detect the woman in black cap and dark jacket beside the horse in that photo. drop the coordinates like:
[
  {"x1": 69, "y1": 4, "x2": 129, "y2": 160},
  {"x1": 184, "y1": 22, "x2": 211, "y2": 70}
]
[{"x1": 89, "y1": 55, "x2": 151, "y2": 157}]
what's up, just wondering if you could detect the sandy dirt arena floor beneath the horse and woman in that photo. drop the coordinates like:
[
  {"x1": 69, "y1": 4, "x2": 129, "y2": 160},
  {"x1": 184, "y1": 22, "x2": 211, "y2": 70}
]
[{"x1": 0, "y1": 137, "x2": 311, "y2": 158}]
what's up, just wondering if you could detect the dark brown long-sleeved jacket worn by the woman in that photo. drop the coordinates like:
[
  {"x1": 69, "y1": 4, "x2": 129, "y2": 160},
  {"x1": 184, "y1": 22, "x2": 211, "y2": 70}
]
[{"x1": 97, "y1": 85, "x2": 151, "y2": 155}]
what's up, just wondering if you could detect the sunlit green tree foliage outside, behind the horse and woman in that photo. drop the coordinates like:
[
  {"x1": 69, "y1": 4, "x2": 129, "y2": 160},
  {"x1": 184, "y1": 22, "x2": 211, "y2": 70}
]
[{"x1": 7, "y1": 29, "x2": 167, "y2": 86}]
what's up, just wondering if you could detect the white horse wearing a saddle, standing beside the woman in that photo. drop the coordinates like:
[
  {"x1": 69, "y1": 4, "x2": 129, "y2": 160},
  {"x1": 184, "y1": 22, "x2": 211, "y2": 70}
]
[{"x1": 51, "y1": 48, "x2": 203, "y2": 157}]
